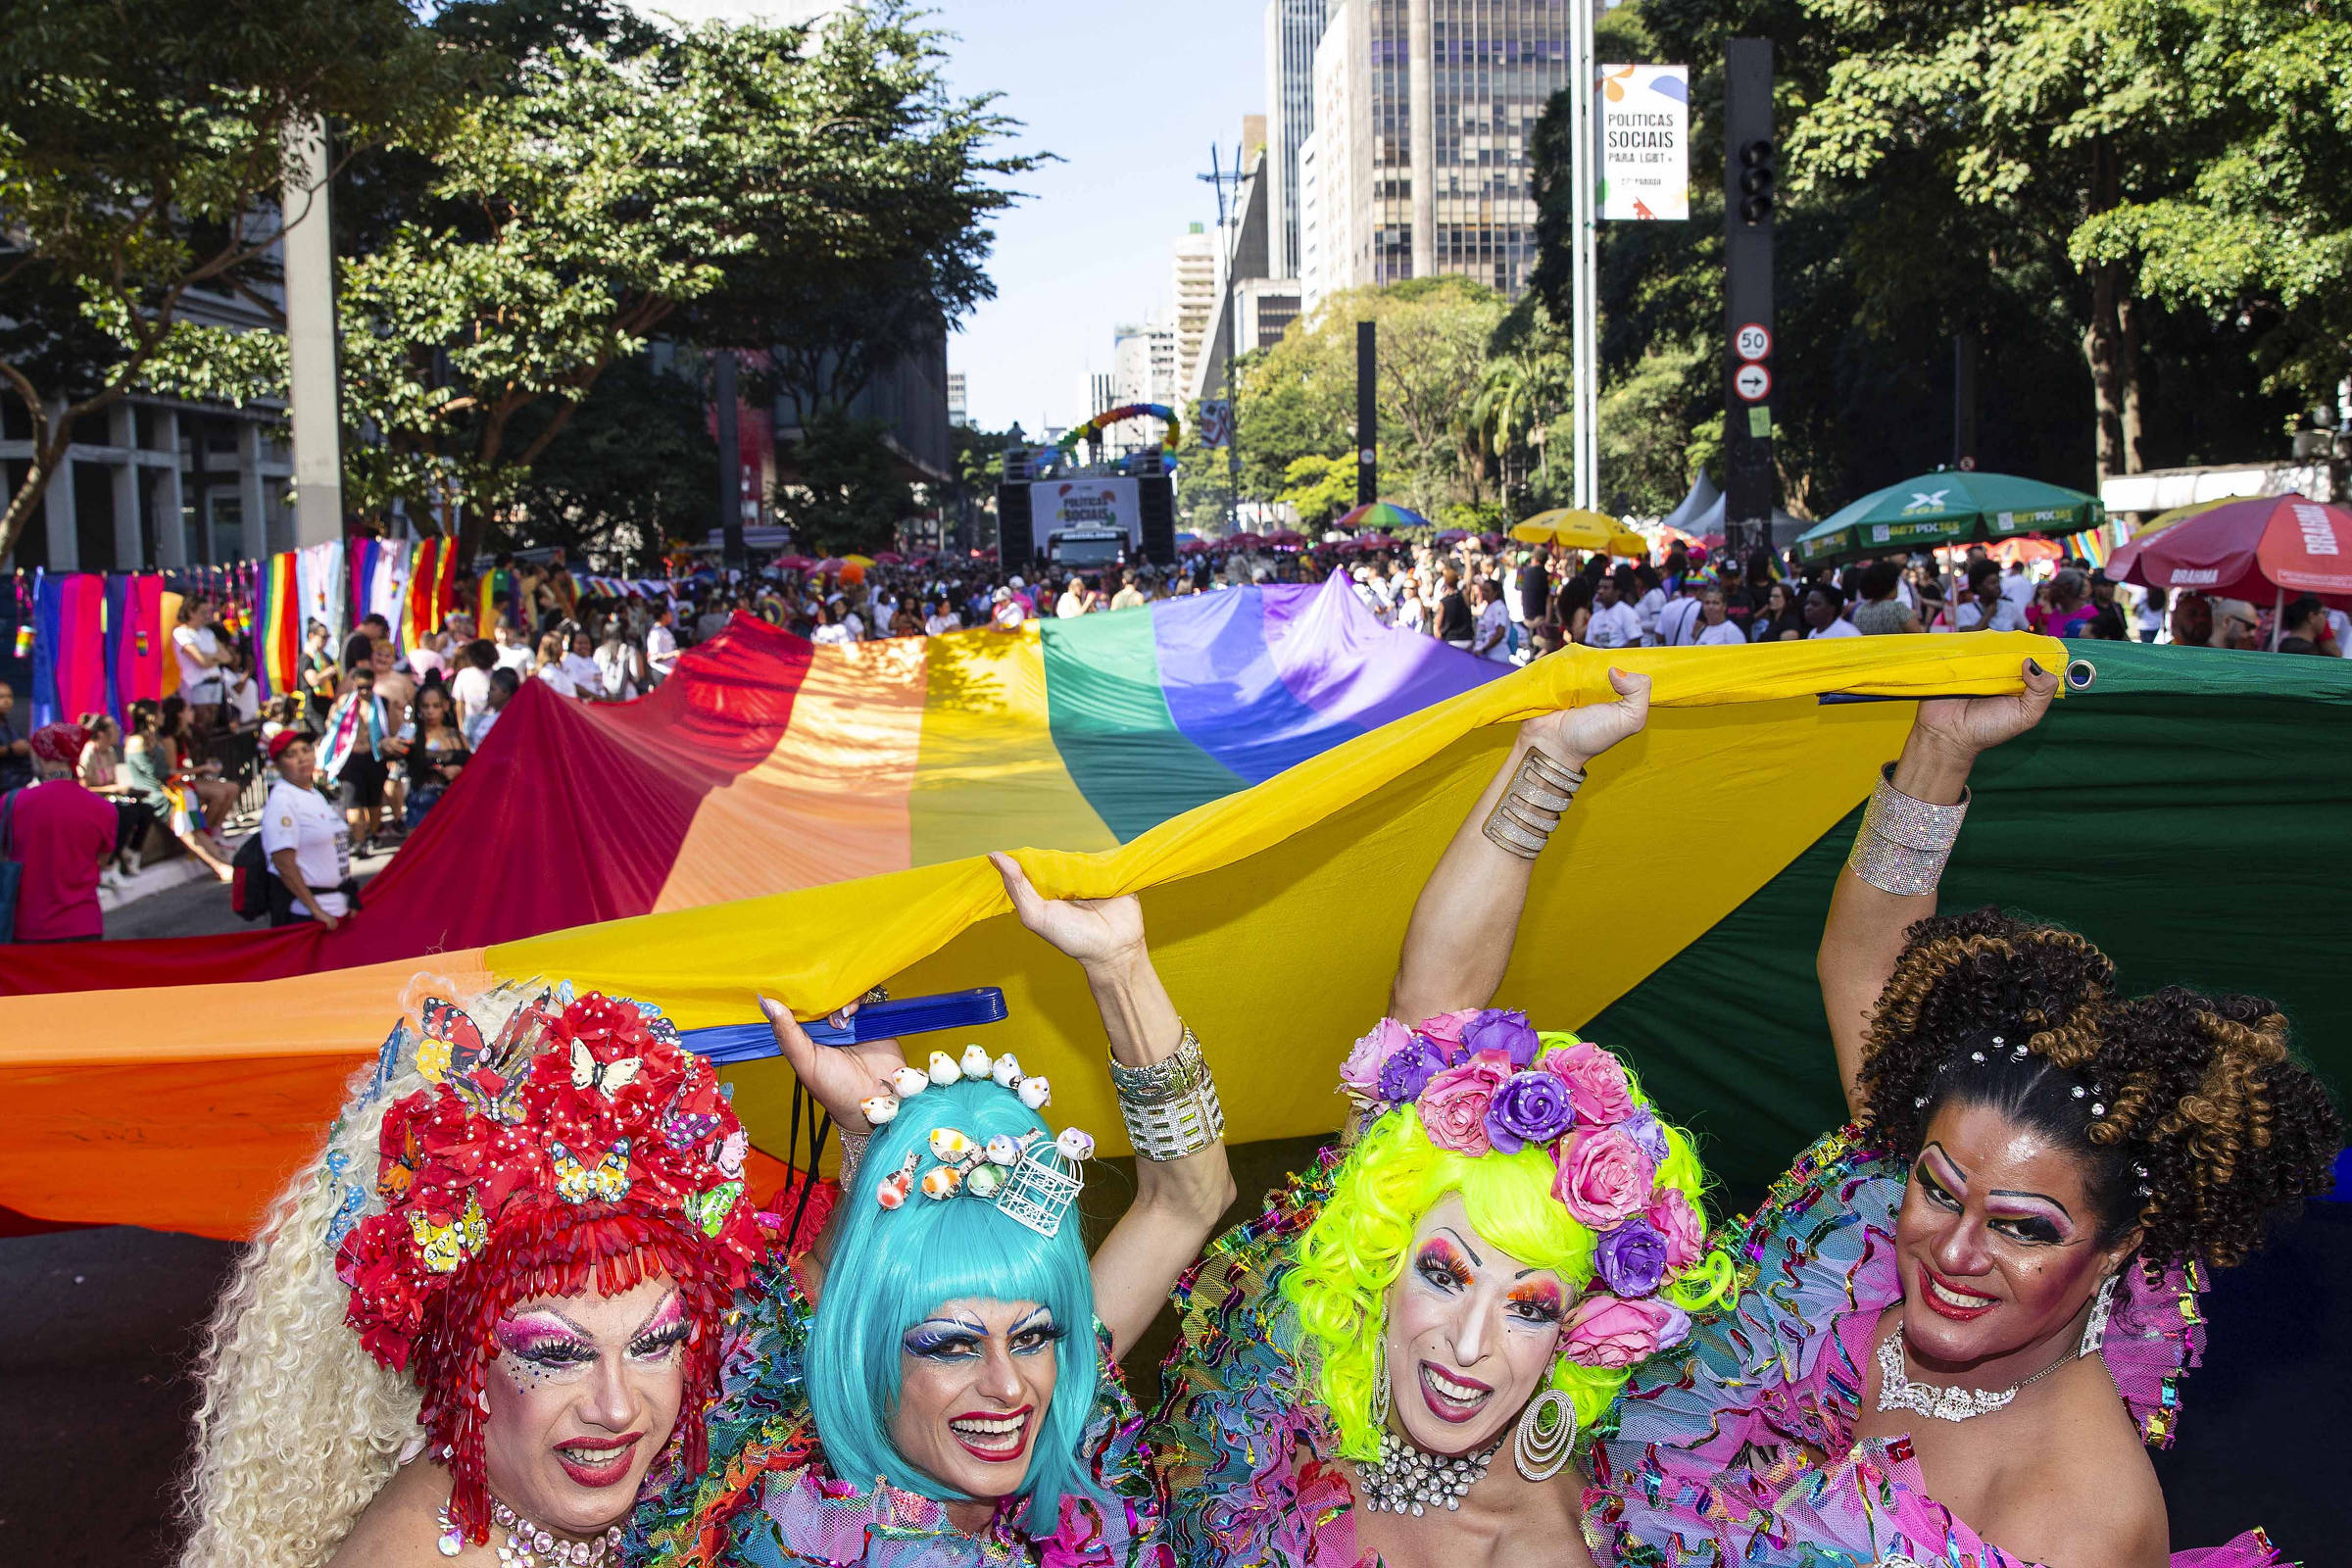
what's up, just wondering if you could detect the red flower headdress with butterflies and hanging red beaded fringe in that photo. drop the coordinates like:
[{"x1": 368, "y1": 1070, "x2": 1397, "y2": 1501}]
[{"x1": 336, "y1": 992, "x2": 766, "y2": 1543}]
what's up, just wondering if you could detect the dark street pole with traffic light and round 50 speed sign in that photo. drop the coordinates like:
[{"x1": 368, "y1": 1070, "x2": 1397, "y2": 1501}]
[{"x1": 1724, "y1": 37, "x2": 1778, "y2": 564}]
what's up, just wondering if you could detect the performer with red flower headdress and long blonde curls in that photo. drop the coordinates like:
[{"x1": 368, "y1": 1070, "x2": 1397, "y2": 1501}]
[{"x1": 181, "y1": 978, "x2": 769, "y2": 1568}]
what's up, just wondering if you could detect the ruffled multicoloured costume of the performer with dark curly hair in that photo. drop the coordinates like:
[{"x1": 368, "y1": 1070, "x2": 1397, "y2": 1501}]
[{"x1": 1586, "y1": 1128, "x2": 2283, "y2": 1568}]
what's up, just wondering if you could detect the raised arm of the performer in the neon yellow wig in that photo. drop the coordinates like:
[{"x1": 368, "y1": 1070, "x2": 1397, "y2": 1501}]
[{"x1": 1388, "y1": 670, "x2": 1648, "y2": 1022}]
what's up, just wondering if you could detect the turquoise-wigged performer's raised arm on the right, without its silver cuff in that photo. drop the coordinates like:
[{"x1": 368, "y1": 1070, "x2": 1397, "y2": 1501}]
[{"x1": 988, "y1": 856, "x2": 1233, "y2": 1354}]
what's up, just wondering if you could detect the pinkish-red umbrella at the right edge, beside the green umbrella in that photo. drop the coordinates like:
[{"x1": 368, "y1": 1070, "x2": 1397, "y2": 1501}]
[{"x1": 2107, "y1": 494, "x2": 2352, "y2": 647}]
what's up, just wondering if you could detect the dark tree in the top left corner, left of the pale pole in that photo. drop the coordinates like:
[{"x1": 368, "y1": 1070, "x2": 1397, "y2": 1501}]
[{"x1": 0, "y1": 0, "x2": 449, "y2": 555}]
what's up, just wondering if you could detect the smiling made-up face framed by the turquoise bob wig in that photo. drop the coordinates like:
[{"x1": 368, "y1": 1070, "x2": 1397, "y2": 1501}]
[{"x1": 889, "y1": 1300, "x2": 1068, "y2": 1499}]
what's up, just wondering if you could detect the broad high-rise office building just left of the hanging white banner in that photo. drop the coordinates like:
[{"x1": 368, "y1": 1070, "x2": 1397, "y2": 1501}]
[{"x1": 1298, "y1": 0, "x2": 1569, "y2": 308}]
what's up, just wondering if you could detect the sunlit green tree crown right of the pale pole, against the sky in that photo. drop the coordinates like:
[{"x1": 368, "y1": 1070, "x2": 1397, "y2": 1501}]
[{"x1": 343, "y1": 10, "x2": 1030, "y2": 566}]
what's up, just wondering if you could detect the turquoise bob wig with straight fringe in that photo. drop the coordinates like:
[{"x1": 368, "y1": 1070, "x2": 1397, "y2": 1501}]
[{"x1": 809, "y1": 1081, "x2": 1099, "y2": 1519}]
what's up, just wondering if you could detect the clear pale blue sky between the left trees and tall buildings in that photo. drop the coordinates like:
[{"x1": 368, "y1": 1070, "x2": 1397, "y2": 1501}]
[{"x1": 630, "y1": 0, "x2": 1265, "y2": 435}]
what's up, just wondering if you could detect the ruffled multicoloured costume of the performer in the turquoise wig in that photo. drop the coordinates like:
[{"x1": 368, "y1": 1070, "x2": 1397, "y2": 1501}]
[{"x1": 623, "y1": 1262, "x2": 1166, "y2": 1568}]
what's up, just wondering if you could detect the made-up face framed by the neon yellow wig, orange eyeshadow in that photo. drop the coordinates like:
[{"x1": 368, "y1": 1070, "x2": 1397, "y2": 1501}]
[{"x1": 1383, "y1": 1192, "x2": 1569, "y2": 1455}]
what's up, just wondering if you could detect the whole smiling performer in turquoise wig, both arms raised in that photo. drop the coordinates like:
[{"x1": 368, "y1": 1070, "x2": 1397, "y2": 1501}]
[{"x1": 628, "y1": 856, "x2": 1233, "y2": 1568}]
